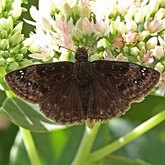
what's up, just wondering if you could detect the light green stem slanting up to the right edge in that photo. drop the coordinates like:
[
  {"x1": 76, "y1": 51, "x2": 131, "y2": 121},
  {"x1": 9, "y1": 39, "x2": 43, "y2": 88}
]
[{"x1": 88, "y1": 110, "x2": 165, "y2": 161}]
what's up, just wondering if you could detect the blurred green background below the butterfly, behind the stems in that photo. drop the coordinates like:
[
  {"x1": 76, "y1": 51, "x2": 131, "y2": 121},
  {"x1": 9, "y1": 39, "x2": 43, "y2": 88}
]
[{"x1": 0, "y1": 96, "x2": 165, "y2": 165}]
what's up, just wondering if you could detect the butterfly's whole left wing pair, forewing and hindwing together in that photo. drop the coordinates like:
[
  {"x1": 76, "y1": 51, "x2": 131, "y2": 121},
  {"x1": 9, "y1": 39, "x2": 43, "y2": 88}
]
[{"x1": 5, "y1": 62, "x2": 85, "y2": 124}]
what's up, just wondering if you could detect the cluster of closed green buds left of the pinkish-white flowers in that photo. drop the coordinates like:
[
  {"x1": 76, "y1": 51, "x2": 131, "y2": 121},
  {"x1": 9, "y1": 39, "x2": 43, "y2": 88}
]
[{"x1": 0, "y1": 0, "x2": 32, "y2": 74}]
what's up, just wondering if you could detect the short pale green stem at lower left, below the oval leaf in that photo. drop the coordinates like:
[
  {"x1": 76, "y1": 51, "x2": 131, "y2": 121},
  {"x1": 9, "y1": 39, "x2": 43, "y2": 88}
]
[{"x1": 19, "y1": 127, "x2": 41, "y2": 165}]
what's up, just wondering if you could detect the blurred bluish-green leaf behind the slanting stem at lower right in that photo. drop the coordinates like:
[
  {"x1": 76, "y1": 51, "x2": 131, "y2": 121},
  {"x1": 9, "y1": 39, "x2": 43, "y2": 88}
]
[{"x1": 110, "y1": 118, "x2": 165, "y2": 165}]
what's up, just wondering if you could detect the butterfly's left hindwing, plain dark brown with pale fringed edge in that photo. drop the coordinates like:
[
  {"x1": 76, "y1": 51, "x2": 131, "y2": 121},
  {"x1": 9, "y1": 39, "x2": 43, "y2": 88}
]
[{"x1": 40, "y1": 75, "x2": 86, "y2": 124}]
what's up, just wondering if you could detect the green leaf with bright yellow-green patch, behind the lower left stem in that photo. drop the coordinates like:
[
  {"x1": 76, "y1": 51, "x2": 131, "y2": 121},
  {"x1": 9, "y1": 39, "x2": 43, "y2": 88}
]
[{"x1": 10, "y1": 125, "x2": 84, "y2": 165}]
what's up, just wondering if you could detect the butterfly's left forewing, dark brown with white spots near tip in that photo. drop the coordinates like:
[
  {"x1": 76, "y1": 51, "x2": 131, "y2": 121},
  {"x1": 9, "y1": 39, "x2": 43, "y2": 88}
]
[{"x1": 5, "y1": 62, "x2": 73, "y2": 103}]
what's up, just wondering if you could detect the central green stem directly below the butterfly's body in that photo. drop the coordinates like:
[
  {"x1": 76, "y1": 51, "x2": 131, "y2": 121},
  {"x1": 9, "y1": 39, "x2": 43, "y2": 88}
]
[{"x1": 71, "y1": 123, "x2": 100, "y2": 165}]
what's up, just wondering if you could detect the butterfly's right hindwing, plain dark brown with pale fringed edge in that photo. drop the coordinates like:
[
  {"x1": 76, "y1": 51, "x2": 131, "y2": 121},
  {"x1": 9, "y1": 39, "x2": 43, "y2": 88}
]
[{"x1": 87, "y1": 75, "x2": 129, "y2": 121}]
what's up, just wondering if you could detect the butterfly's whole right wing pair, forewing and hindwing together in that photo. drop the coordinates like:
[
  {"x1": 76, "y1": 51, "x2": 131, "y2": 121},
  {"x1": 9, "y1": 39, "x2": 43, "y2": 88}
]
[{"x1": 87, "y1": 61, "x2": 160, "y2": 120}]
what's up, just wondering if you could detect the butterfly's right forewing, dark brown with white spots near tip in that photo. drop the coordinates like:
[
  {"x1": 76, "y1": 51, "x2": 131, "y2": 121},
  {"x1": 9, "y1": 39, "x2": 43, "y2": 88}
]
[{"x1": 92, "y1": 61, "x2": 160, "y2": 101}]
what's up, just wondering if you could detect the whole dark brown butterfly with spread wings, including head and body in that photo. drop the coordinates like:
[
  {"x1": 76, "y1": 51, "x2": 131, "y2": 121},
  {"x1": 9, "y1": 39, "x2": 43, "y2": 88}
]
[{"x1": 6, "y1": 48, "x2": 160, "y2": 124}]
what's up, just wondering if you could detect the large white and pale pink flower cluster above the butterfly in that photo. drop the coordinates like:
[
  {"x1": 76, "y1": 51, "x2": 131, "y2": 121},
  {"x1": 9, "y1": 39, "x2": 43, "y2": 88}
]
[{"x1": 1, "y1": 0, "x2": 165, "y2": 95}]
